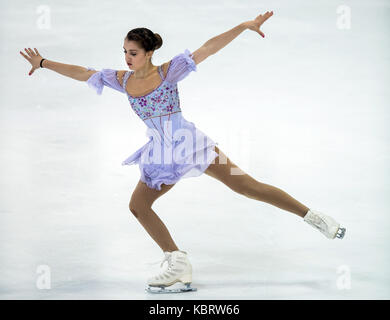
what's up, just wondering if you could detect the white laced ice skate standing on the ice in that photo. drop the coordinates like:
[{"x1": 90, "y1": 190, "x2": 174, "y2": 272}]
[{"x1": 146, "y1": 250, "x2": 197, "y2": 293}]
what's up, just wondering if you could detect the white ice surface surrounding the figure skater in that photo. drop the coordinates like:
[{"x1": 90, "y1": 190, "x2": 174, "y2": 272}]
[{"x1": 0, "y1": 0, "x2": 390, "y2": 299}]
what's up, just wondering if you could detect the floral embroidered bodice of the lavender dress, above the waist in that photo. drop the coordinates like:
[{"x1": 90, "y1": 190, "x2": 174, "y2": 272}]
[{"x1": 123, "y1": 66, "x2": 181, "y2": 121}]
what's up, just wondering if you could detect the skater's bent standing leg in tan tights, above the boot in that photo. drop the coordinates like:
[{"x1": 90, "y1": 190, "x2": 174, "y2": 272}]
[{"x1": 129, "y1": 180, "x2": 179, "y2": 252}]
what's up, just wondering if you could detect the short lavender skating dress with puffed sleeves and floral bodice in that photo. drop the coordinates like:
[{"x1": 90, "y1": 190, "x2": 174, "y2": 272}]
[{"x1": 87, "y1": 49, "x2": 218, "y2": 190}]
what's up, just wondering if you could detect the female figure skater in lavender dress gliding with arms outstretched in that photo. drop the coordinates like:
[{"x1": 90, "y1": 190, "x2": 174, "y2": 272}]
[{"x1": 20, "y1": 11, "x2": 345, "y2": 292}]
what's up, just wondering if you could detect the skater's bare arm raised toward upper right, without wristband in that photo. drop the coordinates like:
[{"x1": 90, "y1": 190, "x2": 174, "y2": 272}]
[{"x1": 193, "y1": 11, "x2": 273, "y2": 64}]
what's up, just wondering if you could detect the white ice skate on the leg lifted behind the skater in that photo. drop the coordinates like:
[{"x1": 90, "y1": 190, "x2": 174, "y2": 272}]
[{"x1": 303, "y1": 210, "x2": 345, "y2": 239}]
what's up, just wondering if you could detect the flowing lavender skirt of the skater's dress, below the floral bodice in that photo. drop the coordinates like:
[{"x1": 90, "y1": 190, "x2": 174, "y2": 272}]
[{"x1": 122, "y1": 112, "x2": 218, "y2": 190}]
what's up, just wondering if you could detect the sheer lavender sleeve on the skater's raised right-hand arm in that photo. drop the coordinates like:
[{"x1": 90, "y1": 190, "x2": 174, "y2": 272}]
[{"x1": 166, "y1": 49, "x2": 197, "y2": 83}]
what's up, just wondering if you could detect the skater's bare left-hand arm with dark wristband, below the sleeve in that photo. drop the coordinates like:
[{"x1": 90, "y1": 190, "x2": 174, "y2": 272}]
[{"x1": 20, "y1": 48, "x2": 97, "y2": 81}]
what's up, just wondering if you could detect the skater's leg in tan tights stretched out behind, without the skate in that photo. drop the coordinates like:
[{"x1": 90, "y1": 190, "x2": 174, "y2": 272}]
[{"x1": 205, "y1": 147, "x2": 309, "y2": 218}]
